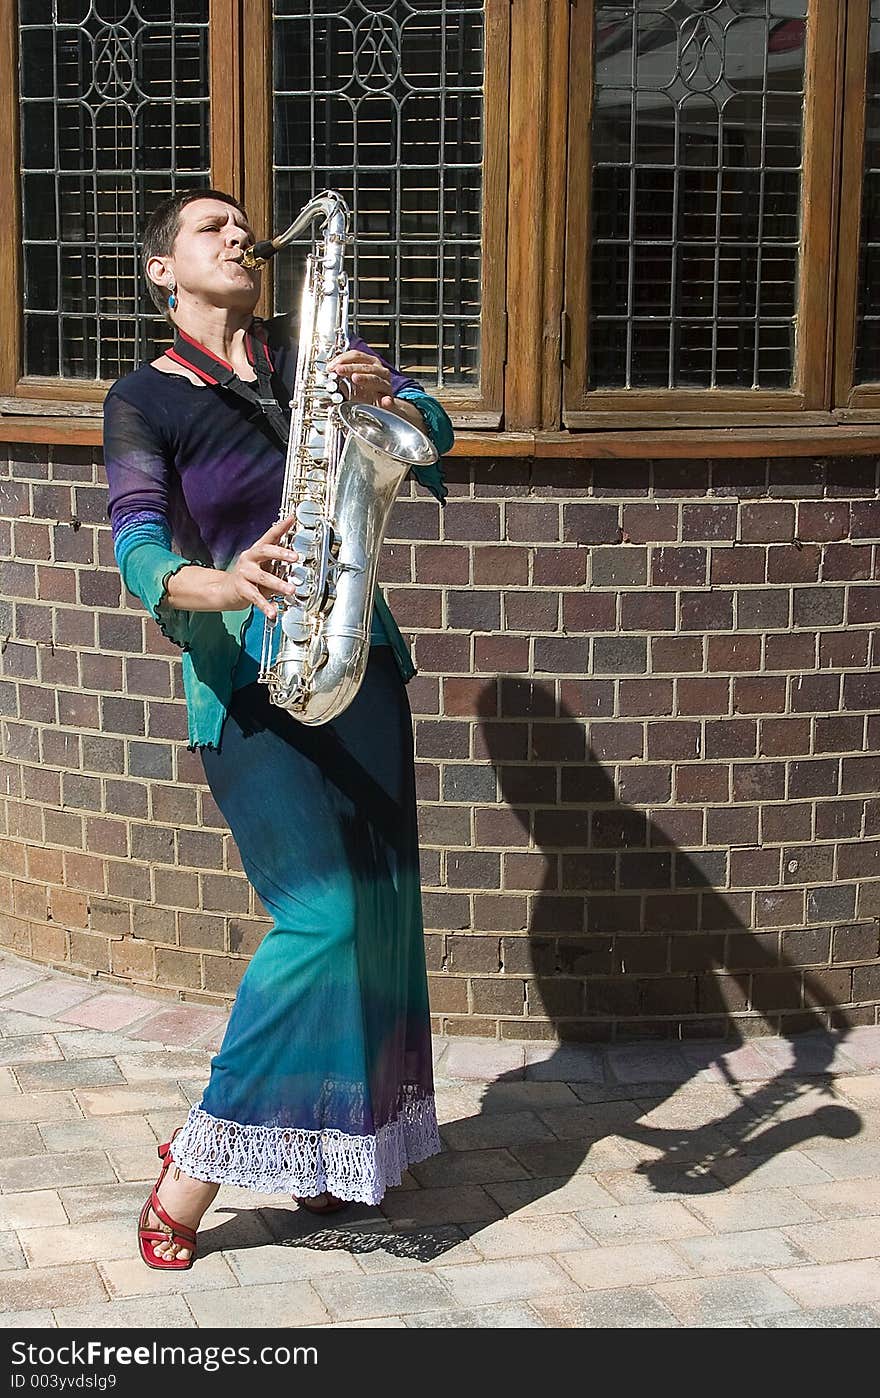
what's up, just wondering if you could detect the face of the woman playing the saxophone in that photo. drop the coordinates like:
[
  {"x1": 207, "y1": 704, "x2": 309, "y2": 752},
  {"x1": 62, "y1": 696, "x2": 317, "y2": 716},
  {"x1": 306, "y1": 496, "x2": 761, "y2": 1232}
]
[{"x1": 151, "y1": 199, "x2": 260, "y2": 310}]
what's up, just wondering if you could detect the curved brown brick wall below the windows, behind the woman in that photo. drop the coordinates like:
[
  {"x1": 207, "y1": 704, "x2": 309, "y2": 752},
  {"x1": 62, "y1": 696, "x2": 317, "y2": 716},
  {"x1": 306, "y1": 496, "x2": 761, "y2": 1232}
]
[{"x1": 0, "y1": 446, "x2": 880, "y2": 1039}]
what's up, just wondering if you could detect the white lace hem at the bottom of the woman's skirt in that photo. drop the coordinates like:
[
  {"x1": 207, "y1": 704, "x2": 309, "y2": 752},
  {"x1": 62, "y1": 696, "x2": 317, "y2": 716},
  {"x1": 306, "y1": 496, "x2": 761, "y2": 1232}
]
[{"x1": 171, "y1": 1089, "x2": 442, "y2": 1204}]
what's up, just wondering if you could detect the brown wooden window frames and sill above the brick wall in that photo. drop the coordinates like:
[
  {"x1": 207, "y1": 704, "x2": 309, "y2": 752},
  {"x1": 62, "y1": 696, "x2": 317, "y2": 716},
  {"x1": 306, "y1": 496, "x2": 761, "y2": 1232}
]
[{"x1": 0, "y1": 0, "x2": 880, "y2": 459}]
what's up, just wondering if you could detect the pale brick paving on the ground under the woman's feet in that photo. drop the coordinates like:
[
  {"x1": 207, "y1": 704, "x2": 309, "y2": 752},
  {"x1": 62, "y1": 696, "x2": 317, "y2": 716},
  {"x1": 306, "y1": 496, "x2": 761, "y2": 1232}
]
[{"x1": 0, "y1": 953, "x2": 880, "y2": 1329}]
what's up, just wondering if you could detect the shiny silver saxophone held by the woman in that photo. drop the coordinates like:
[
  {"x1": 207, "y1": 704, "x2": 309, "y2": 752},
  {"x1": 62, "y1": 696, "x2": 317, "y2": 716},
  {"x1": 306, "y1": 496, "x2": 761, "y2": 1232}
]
[{"x1": 242, "y1": 190, "x2": 438, "y2": 726}]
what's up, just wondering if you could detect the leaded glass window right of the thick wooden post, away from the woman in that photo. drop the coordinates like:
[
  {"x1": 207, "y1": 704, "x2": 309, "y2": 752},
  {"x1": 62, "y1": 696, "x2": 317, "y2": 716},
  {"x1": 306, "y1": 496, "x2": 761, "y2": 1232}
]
[{"x1": 589, "y1": 0, "x2": 807, "y2": 389}]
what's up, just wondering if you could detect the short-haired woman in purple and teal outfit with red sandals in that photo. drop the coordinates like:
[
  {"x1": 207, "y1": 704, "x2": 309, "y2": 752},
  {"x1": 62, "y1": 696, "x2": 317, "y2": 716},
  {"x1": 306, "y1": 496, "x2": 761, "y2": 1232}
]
[{"x1": 105, "y1": 190, "x2": 452, "y2": 1268}]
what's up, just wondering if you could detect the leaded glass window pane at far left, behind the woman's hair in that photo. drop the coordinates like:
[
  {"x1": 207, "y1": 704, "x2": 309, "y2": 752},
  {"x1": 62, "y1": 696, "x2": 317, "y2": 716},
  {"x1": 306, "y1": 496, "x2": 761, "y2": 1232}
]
[{"x1": 18, "y1": 0, "x2": 210, "y2": 379}]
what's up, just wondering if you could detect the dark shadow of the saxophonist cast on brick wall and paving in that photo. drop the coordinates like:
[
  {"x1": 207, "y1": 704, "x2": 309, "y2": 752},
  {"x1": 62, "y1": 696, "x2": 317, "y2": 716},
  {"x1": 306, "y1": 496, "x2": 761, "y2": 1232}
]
[{"x1": 467, "y1": 677, "x2": 860, "y2": 1194}]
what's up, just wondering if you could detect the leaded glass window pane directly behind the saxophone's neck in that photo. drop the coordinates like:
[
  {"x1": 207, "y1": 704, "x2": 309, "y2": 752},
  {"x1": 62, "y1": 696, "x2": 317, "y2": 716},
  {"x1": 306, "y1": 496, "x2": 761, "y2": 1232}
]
[{"x1": 273, "y1": 0, "x2": 484, "y2": 387}]
